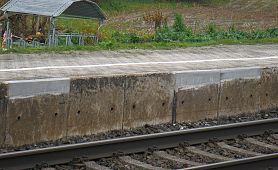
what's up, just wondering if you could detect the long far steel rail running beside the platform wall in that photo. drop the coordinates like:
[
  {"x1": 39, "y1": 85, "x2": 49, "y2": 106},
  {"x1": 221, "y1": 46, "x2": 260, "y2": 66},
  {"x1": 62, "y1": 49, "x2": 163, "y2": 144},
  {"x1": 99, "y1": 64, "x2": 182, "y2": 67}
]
[{"x1": 0, "y1": 118, "x2": 278, "y2": 170}]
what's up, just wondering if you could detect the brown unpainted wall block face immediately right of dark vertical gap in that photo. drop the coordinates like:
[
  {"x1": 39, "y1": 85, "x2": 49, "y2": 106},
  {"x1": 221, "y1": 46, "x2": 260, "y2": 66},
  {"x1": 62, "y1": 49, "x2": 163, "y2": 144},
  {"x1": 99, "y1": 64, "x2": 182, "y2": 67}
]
[{"x1": 176, "y1": 84, "x2": 219, "y2": 122}]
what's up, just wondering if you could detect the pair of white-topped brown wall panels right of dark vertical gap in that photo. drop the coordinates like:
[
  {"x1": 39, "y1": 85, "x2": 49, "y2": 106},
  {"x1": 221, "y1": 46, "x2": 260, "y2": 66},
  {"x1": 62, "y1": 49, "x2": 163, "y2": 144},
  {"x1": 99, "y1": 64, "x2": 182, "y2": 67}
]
[{"x1": 176, "y1": 67, "x2": 261, "y2": 119}]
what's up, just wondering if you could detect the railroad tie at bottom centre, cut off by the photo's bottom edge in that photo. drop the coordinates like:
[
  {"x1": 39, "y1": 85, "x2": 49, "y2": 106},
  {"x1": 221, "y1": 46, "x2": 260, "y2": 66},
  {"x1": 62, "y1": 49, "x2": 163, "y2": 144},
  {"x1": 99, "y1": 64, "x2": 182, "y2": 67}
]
[{"x1": 120, "y1": 156, "x2": 165, "y2": 170}]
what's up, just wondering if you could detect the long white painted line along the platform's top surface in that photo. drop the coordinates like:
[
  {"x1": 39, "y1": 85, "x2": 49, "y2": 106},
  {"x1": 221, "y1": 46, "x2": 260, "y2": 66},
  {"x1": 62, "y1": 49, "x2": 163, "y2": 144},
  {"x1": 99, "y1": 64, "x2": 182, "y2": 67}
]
[{"x1": 0, "y1": 56, "x2": 278, "y2": 72}]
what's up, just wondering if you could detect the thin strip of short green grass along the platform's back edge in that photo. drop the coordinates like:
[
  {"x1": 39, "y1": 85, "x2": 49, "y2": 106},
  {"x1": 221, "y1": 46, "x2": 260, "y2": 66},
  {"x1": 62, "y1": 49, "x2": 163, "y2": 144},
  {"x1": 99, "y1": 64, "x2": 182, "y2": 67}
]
[{"x1": 0, "y1": 38, "x2": 278, "y2": 54}]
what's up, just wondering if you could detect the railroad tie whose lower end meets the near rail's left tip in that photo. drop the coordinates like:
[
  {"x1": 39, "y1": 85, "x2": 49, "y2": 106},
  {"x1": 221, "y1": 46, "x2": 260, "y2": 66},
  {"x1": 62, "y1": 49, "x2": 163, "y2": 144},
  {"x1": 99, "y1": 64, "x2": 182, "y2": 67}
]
[{"x1": 154, "y1": 151, "x2": 202, "y2": 166}]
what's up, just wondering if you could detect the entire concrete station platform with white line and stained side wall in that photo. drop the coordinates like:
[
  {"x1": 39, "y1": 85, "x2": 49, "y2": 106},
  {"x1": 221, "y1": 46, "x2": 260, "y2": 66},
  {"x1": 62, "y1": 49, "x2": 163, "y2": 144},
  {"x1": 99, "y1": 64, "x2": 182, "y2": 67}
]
[{"x1": 0, "y1": 45, "x2": 278, "y2": 146}]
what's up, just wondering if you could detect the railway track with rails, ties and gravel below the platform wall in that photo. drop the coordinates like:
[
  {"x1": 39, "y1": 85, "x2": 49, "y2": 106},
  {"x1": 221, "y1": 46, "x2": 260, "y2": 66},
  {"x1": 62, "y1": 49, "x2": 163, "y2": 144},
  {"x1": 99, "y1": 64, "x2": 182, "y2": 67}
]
[{"x1": 0, "y1": 118, "x2": 278, "y2": 170}]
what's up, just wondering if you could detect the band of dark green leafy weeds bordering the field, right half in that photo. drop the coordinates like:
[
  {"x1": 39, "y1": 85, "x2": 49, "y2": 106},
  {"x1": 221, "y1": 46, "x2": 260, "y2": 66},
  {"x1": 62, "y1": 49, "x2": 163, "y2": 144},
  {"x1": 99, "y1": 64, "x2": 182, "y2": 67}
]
[{"x1": 154, "y1": 21, "x2": 278, "y2": 42}]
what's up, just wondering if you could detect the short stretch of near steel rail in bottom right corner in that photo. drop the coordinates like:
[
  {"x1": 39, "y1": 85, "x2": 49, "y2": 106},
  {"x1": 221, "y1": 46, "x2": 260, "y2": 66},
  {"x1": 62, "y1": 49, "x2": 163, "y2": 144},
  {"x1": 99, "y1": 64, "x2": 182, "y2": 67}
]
[{"x1": 184, "y1": 153, "x2": 278, "y2": 170}]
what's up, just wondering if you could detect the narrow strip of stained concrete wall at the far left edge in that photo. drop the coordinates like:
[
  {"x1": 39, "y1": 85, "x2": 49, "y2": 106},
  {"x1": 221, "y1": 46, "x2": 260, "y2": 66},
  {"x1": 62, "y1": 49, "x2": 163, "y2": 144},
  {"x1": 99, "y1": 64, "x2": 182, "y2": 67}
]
[{"x1": 0, "y1": 83, "x2": 7, "y2": 147}]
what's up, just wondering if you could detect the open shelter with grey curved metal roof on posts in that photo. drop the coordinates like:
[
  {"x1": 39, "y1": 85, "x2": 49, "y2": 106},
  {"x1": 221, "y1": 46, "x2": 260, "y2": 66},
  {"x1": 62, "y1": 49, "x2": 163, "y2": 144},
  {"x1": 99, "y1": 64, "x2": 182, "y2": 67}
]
[{"x1": 0, "y1": 0, "x2": 106, "y2": 48}]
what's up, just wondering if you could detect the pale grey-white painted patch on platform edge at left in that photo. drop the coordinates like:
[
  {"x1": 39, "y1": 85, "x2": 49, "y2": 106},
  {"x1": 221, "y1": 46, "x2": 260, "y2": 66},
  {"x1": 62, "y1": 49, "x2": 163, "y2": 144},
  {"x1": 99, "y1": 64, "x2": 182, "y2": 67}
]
[{"x1": 4, "y1": 78, "x2": 70, "y2": 99}]
